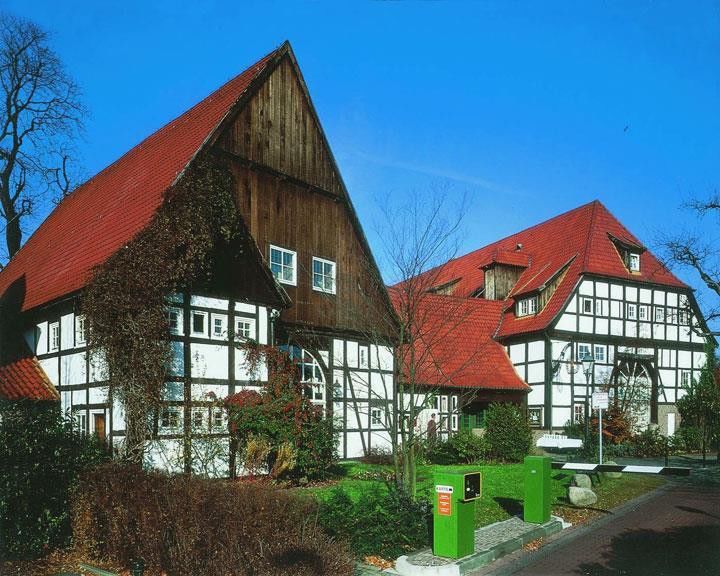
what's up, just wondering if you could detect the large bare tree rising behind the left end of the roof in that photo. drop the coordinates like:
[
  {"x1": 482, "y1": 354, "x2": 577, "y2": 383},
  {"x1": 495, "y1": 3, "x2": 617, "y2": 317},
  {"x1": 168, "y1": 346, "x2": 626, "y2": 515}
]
[{"x1": 0, "y1": 13, "x2": 86, "y2": 258}]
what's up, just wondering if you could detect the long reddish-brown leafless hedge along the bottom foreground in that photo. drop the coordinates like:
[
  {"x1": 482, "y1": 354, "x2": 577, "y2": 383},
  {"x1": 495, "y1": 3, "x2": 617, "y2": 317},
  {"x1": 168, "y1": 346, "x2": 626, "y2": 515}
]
[{"x1": 72, "y1": 463, "x2": 353, "y2": 576}]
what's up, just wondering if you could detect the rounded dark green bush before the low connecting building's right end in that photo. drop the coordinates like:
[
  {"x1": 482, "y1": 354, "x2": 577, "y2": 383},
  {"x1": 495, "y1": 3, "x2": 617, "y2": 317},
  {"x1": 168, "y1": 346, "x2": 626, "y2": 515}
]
[{"x1": 485, "y1": 403, "x2": 532, "y2": 462}]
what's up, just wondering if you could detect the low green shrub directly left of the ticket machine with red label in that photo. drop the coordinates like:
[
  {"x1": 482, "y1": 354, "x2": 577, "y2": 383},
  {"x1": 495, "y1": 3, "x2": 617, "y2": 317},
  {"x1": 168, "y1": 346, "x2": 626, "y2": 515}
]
[{"x1": 319, "y1": 484, "x2": 431, "y2": 558}]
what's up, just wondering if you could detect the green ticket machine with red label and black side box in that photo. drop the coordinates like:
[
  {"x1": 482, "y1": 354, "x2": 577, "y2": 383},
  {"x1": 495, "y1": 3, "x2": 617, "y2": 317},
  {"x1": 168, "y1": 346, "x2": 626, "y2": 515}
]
[{"x1": 433, "y1": 470, "x2": 482, "y2": 558}]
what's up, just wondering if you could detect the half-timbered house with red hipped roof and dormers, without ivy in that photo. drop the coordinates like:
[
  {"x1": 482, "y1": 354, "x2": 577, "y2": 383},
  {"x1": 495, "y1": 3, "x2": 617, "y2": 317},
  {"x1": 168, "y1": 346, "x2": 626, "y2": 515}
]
[{"x1": 422, "y1": 201, "x2": 704, "y2": 434}]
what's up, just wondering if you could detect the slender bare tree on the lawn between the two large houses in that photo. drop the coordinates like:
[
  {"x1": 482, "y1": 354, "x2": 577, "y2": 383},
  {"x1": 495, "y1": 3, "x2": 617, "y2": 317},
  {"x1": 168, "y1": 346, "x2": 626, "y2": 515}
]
[{"x1": 348, "y1": 188, "x2": 489, "y2": 496}]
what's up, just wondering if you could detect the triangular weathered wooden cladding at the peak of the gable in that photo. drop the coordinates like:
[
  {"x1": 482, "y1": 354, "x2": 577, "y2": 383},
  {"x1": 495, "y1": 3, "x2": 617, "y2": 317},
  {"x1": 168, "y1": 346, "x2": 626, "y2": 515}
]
[{"x1": 221, "y1": 54, "x2": 344, "y2": 196}]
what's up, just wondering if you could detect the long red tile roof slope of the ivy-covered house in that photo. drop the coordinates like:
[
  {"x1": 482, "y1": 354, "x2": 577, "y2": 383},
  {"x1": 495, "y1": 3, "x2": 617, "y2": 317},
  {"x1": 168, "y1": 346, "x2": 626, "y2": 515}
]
[{"x1": 0, "y1": 45, "x2": 285, "y2": 311}]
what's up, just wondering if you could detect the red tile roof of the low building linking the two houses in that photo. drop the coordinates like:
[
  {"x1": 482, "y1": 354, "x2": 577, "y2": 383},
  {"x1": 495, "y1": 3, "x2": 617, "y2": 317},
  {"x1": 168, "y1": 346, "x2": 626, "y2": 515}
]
[{"x1": 390, "y1": 289, "x2": 530, "y2": 392}]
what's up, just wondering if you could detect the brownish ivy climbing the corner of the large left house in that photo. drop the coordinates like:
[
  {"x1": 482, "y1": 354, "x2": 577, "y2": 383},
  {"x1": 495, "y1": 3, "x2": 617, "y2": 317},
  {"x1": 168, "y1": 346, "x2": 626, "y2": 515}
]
[{"x1": 81, "y1": 156, "x2": 244, "y2": 463}]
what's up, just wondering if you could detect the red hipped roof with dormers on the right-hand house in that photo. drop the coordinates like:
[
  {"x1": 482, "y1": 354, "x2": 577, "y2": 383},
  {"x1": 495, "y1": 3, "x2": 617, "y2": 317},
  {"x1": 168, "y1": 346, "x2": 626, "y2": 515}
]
[{"x1": 420, "y1": 200, "x2": 687, "y2": 338}]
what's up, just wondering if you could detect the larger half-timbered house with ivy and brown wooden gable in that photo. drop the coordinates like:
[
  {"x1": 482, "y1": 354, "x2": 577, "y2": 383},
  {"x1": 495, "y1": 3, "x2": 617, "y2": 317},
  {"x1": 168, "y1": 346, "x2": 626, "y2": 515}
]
[{"x1": 0, "y1": 43, "x2": 394, "y2": 473}]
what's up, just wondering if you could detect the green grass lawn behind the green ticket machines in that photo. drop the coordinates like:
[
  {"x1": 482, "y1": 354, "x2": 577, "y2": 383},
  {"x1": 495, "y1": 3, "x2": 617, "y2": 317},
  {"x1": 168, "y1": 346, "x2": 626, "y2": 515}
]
[{"x1": 308, "y1": 462, "x2": 665, "y2": 526}]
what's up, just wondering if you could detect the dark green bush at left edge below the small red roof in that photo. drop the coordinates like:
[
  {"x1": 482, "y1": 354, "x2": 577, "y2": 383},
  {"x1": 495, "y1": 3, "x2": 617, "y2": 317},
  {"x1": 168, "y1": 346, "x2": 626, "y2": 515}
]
[{"x1": 0, "y1": 402, "x2": 107, "y2": 558}]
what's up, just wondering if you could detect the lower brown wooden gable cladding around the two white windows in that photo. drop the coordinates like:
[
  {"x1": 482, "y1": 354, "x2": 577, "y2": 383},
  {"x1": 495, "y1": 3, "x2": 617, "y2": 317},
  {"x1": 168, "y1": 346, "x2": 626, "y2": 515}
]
[{"x1": 233, "y1": 161, "x2": 390, "y2": 334}]
